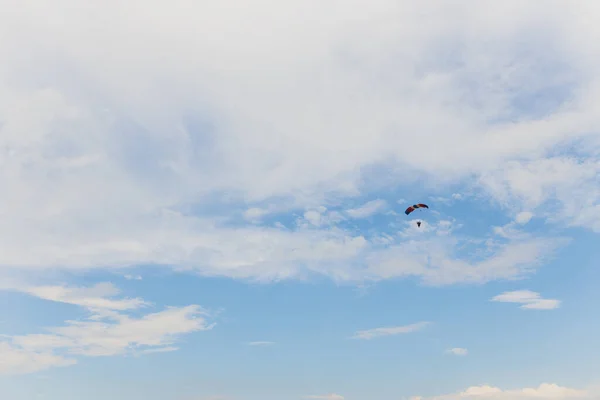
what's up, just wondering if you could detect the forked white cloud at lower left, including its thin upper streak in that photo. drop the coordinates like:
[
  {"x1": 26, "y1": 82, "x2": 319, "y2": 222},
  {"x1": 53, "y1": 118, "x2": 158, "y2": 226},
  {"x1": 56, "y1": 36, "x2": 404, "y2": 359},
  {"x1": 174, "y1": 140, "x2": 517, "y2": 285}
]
[{"x1": 0, "y1": 283, "x2": 214, "y2": 374}]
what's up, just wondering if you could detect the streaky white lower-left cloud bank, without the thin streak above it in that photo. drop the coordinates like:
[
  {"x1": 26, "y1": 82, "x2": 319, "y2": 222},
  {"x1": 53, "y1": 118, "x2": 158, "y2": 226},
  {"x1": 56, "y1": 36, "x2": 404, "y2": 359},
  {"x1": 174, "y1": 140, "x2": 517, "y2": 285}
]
[{"x1": 0, "y1": 306, "x2": 212, "y2": 375}]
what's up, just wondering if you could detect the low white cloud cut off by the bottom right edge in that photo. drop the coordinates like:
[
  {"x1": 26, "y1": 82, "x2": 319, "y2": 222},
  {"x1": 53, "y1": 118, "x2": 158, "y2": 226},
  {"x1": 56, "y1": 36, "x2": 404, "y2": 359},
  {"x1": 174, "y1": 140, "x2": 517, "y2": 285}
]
[{"x1": 411, "y1": 383, "x2": 597, "y2": 400}]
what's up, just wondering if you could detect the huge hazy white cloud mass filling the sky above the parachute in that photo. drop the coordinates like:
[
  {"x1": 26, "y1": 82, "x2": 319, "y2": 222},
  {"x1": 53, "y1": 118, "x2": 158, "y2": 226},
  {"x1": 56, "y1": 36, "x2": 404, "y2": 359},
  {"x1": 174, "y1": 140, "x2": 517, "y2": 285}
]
[{"x1": 0, "y1": 0, "x2": 600, "y2": 288}]
